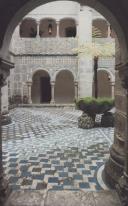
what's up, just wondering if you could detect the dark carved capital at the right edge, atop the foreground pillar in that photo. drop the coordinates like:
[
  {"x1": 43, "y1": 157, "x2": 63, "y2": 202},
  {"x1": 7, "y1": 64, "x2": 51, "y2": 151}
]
[{"x1": 118, "y1": 62, "x2": 128, "y2": 89}]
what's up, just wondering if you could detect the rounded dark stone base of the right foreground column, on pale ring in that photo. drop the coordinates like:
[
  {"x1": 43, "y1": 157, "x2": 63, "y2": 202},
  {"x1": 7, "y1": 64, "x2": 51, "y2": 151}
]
[{"x1": 104, "y1": 147, "x2": 124, "y2": 188}]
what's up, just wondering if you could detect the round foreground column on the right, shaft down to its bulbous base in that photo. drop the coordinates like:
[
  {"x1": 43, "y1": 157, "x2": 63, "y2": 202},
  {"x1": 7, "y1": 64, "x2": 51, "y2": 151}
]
[{"x1": 104, "y1": 64, "x2": 127, "y2": 187}]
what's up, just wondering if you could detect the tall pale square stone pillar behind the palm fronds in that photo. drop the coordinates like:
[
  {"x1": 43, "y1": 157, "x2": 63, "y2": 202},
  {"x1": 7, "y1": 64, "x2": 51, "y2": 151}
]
[{"x1": 78, "y1": 6, "x2": 93, "y2": 97}]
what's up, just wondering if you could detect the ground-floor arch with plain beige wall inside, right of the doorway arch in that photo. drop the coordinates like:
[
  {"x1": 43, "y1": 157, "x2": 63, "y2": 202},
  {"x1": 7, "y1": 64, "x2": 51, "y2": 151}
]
[{"x1": 55, "y1": 70, "x2": 75, "y2": 103}]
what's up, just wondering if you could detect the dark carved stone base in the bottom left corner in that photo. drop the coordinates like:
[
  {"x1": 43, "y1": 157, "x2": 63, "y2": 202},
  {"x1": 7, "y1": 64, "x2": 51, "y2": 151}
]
[{"x1": 0, "y1": 176, "x2": 11, "y2": 206}]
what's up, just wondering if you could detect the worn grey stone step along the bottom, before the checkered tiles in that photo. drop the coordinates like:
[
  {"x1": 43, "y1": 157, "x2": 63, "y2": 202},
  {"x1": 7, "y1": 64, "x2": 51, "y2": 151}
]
[{"x1": 5, "y1": 190, "x2": 121, "y2": 206}]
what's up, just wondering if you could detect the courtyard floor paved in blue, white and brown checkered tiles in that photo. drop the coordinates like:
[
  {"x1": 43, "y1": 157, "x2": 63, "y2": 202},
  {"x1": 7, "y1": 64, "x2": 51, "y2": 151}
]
[{"x1": 2, "y1": 108, "x2": 114, "y2": 191}]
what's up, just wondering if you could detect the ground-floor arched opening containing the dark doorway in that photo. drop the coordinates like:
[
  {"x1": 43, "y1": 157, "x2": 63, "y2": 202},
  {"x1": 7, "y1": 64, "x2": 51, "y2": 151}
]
[{"x1": 31, "y1": 70, "x2": 51, "y2": 104}]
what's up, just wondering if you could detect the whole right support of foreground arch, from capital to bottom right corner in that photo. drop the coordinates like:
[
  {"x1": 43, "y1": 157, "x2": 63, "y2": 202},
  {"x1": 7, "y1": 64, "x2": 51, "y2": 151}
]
[{"x1": 104, "y1": 63, "x2": 128, "y2": 206}]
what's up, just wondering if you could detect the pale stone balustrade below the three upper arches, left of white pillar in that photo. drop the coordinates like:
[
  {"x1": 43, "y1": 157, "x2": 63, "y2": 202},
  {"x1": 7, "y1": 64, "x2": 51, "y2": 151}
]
[{"x1": 10, "y1": 38, "x2": 77, "y2": 55}]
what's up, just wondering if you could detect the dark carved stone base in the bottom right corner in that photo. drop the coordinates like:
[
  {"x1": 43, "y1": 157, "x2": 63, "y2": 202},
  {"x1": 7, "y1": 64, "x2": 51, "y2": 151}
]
[{"x1": 116, "y1": 175, "x2": 128, "y2": 206}]
